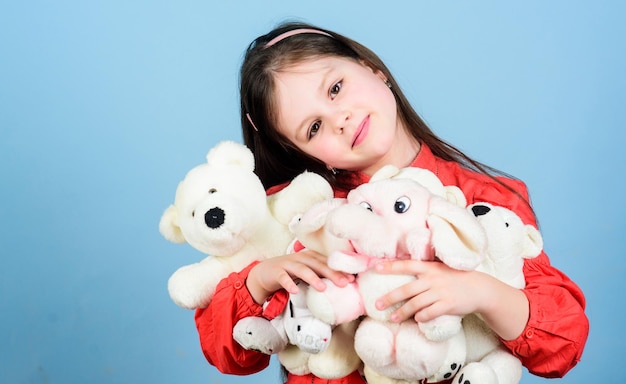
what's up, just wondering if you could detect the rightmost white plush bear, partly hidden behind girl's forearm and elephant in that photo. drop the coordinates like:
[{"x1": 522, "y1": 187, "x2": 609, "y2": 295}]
[{"x1": 456, "y1": 203, "x2": 543, "y2": 384}]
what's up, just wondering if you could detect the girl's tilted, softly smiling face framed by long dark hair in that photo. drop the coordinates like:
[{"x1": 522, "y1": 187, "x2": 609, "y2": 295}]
[{"x1": 275, "y1": 57, "x2": 419, "y2": 174}]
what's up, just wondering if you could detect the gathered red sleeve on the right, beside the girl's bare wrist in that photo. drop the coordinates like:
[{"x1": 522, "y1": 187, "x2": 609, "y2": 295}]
[{"x1": 503, "y1": 253, "x2": 589, "y2": 378}]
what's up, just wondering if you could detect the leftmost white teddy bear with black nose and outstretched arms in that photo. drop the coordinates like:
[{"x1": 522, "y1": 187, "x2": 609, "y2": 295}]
[{"x1": 159, "y1": 141, "x2": 332, "y2": 309}]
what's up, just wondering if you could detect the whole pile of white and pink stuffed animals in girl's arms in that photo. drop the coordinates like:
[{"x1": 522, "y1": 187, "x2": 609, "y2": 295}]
[{"x1": 159, "y1": 142, "x2": 543, "y2": 384}]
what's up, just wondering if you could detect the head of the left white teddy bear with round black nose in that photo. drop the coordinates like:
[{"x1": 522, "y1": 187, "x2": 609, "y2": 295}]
[{"x1": 159, "y1": 141, "x2": 269, "y2": 255}]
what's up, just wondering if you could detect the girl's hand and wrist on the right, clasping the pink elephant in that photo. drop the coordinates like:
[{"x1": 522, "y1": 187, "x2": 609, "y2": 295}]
[{"x1": 376, "y1": 260, "x2": 529, "y2": 340}]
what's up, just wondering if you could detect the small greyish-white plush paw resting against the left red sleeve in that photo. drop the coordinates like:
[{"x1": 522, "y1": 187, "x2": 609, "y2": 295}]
[{"x1": 233, "y1": 317, "x2": 287, "y2": 355}]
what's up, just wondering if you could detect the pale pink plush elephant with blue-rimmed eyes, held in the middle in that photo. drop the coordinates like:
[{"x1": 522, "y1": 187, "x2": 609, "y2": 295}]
[{"x1": 307, "y1": 166, "x2": 486, "y2": 383}]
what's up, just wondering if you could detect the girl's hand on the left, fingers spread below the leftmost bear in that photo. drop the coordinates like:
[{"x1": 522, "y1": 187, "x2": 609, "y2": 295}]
[{"x1": 246, "y1": 250, "x2": 354, "y2": 304}]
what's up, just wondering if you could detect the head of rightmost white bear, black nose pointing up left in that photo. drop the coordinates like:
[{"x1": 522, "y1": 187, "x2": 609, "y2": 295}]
[{"x1": 468, "y1": 202, "x2": 543, "y2": 288}]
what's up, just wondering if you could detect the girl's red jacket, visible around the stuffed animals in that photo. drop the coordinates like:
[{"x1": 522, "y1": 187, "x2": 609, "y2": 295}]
[{"x1": 196, "y1": 145, "x2": 589, "y2": 382}]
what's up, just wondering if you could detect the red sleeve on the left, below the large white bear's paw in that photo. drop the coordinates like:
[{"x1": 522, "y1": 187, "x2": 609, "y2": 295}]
[{"x1": 195, "y1": 262, "x2": 270, "y2": 375}]
